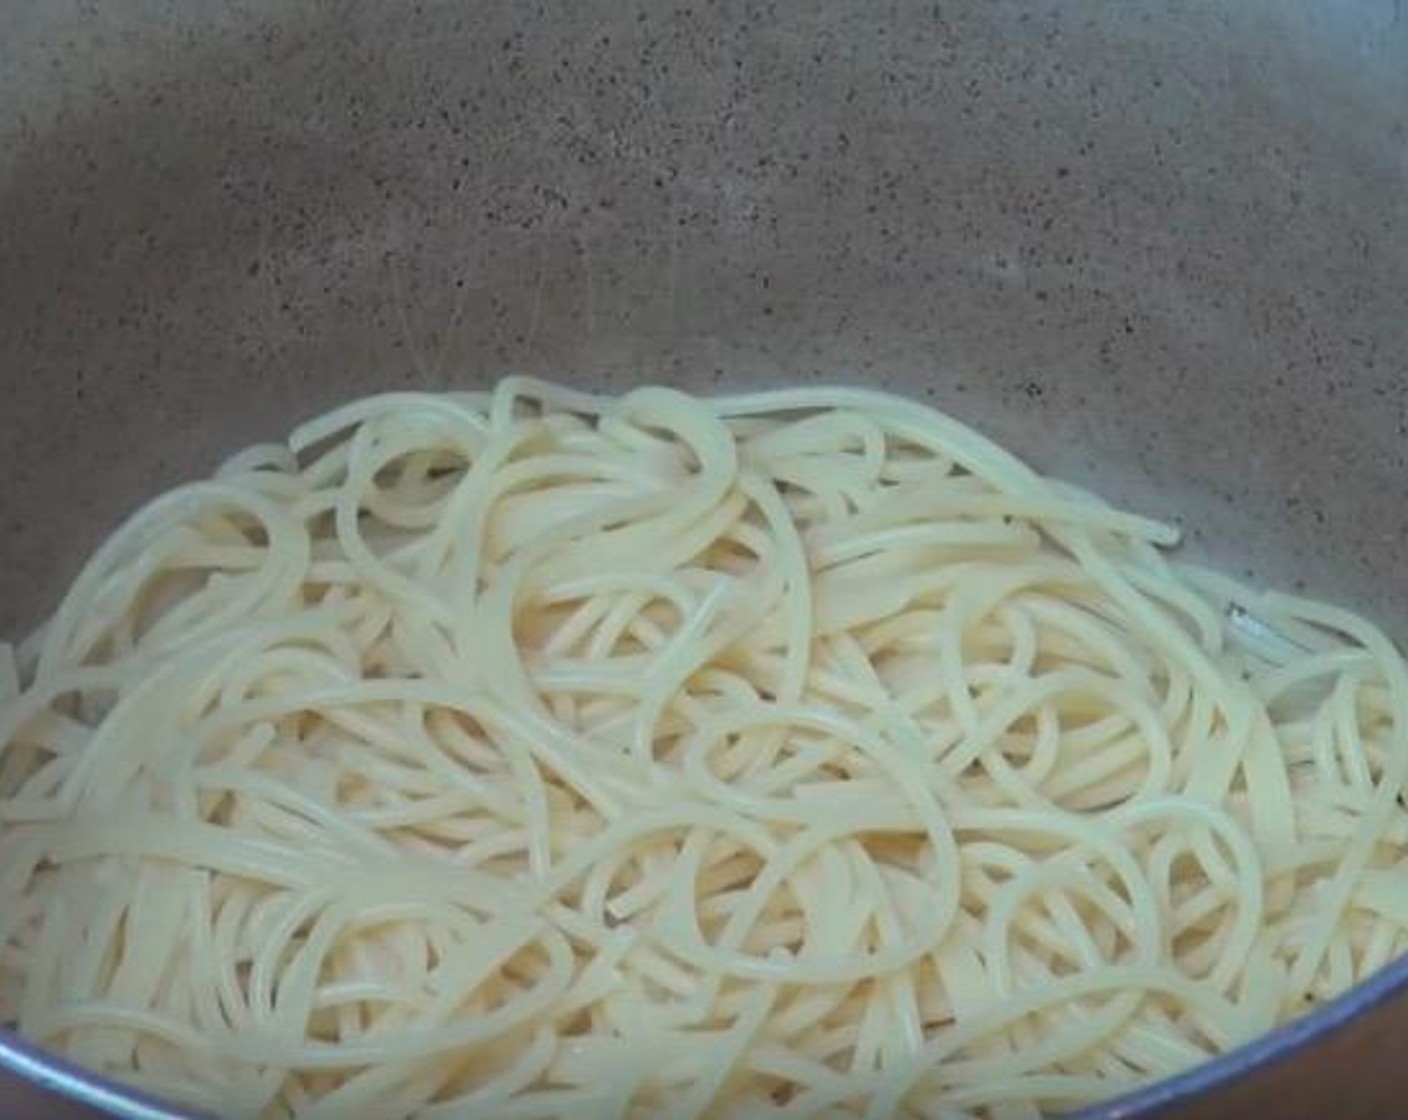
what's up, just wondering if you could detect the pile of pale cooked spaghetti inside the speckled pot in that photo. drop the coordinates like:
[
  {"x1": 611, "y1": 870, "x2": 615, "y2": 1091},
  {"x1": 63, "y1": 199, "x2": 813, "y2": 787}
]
[{"x1": 0, "y1": 379, "x2": 1408, "y2": 1120}]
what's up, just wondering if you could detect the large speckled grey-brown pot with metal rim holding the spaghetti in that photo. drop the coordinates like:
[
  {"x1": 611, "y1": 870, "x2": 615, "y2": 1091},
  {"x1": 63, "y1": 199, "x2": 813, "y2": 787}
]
[{"x1": 0, "y1": 0, "x2": 1408, "y2": 1120}]
